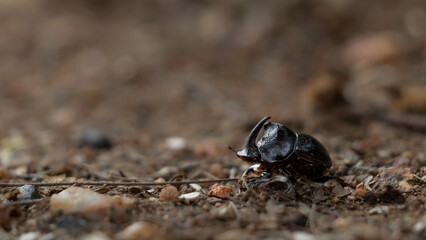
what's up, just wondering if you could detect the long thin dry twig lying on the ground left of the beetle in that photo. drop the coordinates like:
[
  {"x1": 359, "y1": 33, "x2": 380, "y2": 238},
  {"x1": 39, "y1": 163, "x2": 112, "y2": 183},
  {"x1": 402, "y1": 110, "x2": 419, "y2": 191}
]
[{"x1": 0, "y1": 178, "x2": 239, "y2": 187}]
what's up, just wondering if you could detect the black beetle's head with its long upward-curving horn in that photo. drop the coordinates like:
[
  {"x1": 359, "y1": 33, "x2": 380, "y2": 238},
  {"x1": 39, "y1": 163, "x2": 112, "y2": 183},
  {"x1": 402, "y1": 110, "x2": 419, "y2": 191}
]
[{"x1": 236, "y1": 117, "x2": 271, "y2": 163}]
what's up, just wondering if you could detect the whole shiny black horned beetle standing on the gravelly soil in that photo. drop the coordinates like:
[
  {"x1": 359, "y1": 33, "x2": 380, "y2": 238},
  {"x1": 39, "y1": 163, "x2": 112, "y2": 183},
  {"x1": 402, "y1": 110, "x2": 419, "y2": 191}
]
[{"x1": 230, "y1": 117, "x2": 346, "y2": 188}]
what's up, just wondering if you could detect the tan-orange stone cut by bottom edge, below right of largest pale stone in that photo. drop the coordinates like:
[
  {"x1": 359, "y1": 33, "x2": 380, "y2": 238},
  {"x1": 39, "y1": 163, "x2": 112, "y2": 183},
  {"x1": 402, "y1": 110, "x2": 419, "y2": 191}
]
[{"x1": 117, "y1": 222, "x2": 167, "y2": 240}]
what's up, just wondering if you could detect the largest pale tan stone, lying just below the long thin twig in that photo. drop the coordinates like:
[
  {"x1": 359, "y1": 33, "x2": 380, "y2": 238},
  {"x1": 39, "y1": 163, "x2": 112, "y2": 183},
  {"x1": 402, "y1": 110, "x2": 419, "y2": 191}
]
[{"x1": 50, "y1": 187, "x2": 136, "y2": 214}]
